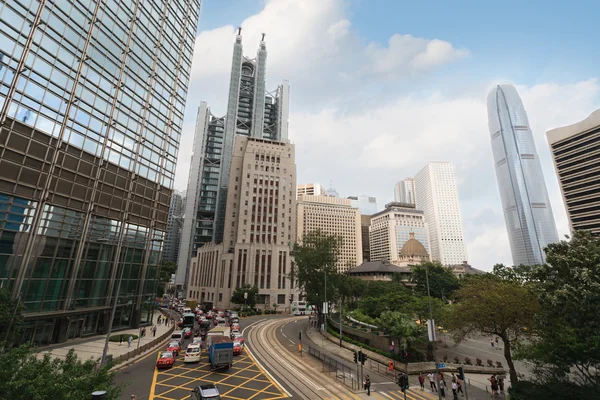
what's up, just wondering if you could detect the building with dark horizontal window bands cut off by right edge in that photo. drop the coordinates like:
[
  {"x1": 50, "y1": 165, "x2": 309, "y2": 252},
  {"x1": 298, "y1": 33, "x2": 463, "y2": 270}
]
[{"x1": 546, "y1": 110, "x2": 600, "y2": 235}]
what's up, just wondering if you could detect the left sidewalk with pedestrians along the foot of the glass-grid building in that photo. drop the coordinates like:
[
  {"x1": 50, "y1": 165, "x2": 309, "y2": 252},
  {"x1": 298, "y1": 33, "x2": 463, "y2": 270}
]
[{"x1": 39, "y1": 310, "x2": 174, "y2": 364}]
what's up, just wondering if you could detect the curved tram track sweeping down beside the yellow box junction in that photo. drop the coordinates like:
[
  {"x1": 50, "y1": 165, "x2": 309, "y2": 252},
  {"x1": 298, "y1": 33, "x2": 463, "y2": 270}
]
[{"x1": 246, "y1": 317, "x2": 351, "y2": 400}]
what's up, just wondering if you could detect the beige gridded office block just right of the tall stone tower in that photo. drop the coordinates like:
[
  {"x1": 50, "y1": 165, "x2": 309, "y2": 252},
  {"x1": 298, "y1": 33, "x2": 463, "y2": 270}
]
[{"x1": 296, "y1": 196, "x2": 363, "y2": 273}]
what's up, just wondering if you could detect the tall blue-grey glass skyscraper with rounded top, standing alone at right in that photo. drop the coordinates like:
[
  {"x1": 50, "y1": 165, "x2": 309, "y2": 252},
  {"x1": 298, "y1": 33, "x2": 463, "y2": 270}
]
[{"x1": 487, "y1": 85, "x2": 558, "y2": 265}]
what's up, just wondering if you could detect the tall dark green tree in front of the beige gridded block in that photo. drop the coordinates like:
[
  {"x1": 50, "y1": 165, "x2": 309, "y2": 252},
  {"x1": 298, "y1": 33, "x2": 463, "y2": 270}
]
[{"x1": 294, "y1": 230, "x2": 342, "y2": 317}]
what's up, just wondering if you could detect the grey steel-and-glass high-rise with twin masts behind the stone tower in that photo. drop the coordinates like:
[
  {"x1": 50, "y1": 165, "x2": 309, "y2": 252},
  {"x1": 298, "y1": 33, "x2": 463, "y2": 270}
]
[{"x1": 176, "y1": 28, "x2": 289, "y2": 288}]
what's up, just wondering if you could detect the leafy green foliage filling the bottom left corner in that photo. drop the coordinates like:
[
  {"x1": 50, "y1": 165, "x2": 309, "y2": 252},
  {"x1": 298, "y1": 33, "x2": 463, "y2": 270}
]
[{"x1": 0, "y1": 346, "x2": 123, "y2": 400}]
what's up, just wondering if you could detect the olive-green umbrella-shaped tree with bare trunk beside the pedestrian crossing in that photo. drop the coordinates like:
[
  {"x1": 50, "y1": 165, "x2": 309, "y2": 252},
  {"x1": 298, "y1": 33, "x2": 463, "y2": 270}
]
[{"x1": 446, "y1": 274, "x2": 540, "y2": 384}]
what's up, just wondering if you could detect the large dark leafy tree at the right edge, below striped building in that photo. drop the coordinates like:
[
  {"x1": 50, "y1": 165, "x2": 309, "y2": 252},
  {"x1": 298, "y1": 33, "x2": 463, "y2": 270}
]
[{"x1": 516, "y1": 231, "x2": 600, "y2": 399}]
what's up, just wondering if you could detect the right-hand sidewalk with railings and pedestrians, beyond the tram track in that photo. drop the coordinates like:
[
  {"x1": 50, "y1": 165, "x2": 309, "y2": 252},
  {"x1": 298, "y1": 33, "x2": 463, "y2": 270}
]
[{"x1": 305, "y1": 326, "x2": 496, "y2": 400}]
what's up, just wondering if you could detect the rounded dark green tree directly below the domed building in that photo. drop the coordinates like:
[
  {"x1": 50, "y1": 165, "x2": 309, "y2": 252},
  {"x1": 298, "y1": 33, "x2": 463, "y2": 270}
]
[{"x1": 412, "y1": 261, "x2": 459, "y2": 300}]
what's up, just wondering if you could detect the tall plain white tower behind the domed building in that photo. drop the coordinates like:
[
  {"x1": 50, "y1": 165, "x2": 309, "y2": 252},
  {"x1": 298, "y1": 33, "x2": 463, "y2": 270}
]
[{"x1": 418, "y1": 161, "x2": 467, "y2": 266}]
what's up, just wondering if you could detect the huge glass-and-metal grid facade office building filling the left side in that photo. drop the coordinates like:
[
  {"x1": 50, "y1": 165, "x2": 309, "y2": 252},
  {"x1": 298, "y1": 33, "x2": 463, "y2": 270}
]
[{"x1": 0, "y1": 0, "x2": 200, "y2": 344}]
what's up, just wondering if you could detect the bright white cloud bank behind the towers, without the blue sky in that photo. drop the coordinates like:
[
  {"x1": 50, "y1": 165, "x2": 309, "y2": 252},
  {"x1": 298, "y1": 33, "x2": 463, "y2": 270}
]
[{"x1": 176, "y1": 0, "x2": 600, "y2": 269}]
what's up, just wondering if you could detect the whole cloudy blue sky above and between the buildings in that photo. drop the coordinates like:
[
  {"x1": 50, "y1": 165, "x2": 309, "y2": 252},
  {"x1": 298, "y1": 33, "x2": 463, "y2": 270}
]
[{"x1": 175, "y1": 0, "x2": 600, "y2": 270}]
